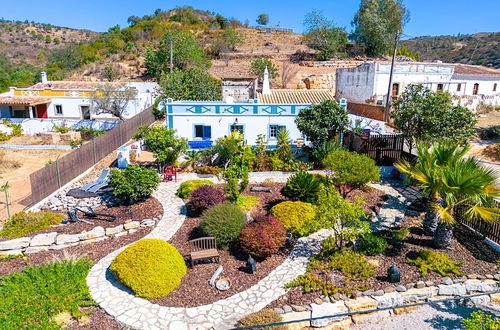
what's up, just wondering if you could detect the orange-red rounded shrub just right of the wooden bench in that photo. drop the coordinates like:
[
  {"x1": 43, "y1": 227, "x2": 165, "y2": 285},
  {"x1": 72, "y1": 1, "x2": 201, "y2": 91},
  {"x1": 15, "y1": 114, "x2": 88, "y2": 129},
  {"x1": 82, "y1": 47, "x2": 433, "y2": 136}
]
[{"x1": 238, "y1": 215, "x2": 286, "y2": 259}]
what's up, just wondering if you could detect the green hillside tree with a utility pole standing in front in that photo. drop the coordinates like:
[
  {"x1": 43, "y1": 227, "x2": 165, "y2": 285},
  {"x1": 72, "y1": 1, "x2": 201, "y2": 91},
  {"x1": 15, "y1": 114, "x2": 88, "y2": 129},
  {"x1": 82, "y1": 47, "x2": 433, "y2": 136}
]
[{"x1": 145, "y1": 30, "x2": 210, "y2": 78}]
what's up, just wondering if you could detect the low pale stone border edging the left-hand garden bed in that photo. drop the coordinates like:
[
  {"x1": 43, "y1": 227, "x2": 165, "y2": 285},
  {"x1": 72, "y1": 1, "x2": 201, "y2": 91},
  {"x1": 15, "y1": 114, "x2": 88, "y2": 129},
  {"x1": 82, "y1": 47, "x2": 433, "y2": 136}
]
[{"x1": 0, "y1": 219, "x2": 156, "y2": 256}]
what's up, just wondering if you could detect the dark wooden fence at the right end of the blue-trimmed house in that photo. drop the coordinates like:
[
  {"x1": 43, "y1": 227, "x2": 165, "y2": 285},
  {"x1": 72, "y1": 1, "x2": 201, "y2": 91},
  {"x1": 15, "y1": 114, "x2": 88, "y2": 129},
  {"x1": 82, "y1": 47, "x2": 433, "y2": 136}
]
[{"x1": 344, "y1": 133, "x2": 415, "y2": 166}]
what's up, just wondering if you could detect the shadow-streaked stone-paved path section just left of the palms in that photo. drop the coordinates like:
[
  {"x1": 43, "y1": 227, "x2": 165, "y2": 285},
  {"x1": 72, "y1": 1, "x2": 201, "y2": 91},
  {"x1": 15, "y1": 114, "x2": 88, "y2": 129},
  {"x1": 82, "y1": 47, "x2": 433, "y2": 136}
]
[{"x1": 370, "y1": 180, "x2": 420, "y2": 231}]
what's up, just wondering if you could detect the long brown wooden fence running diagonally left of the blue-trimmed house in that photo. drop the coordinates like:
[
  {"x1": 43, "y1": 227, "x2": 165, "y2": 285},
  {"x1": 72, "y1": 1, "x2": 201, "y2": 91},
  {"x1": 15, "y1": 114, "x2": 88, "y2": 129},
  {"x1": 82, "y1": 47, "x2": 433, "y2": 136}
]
[{"x1": 30, "y1": 108, "x2": 155, "y2": 205}]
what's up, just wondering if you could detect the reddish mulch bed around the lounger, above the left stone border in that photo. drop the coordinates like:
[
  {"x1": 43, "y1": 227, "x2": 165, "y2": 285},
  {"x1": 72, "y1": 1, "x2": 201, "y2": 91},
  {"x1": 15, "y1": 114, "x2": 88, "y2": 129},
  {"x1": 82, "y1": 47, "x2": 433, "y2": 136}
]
[{"x1": 0, "y1": 197, "x2": 163, "y2": 241}]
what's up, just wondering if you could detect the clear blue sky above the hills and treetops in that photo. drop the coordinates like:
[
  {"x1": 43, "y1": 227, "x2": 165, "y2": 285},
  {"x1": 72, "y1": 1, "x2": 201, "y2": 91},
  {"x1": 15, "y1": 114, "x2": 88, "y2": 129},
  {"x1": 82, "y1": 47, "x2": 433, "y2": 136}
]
[{"x1": 0, "y1": 0, "x2": 500, "y2": 37}]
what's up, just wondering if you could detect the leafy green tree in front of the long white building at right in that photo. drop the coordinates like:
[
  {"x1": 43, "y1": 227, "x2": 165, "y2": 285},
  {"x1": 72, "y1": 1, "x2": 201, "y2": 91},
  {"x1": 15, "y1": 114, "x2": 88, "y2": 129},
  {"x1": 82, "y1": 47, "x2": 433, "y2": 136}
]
[{"x1": 391, "y1": 85, "x2": 476, "y2": 149}]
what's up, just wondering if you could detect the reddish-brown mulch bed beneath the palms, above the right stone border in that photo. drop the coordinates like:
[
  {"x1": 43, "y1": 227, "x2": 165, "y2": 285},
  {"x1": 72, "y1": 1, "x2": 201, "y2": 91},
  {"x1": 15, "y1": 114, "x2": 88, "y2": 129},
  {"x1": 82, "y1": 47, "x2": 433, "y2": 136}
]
[{"x1": 268, "y1": 199, "x2": 500, "y2": 308}]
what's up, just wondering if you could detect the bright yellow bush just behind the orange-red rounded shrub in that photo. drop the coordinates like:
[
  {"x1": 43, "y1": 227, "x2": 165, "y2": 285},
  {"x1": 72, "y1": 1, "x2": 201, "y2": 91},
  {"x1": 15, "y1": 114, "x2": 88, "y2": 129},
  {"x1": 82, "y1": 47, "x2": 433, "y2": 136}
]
[{"x1": 271, "y1": 201, "x2": 319, "y2": 236}]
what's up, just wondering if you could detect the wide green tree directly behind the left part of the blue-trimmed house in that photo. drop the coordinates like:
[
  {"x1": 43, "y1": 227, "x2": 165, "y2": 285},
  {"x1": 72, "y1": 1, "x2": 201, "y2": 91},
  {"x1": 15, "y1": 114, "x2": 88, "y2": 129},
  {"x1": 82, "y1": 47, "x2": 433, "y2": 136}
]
[{"x1": 159, "y1": 68, "x2": 222, "y2": 101}]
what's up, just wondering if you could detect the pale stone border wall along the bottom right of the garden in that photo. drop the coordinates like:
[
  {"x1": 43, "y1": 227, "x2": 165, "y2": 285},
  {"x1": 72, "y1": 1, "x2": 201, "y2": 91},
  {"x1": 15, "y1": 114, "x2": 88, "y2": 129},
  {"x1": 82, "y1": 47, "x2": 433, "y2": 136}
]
[{"x1": 275, "y1": 273, "x2": 500, "y2": 330}]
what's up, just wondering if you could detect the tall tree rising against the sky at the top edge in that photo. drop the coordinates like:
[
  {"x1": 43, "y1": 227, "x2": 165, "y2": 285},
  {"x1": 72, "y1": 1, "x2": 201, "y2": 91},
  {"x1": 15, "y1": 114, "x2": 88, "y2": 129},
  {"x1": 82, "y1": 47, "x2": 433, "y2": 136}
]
[{"x1": 351, "y1": 0, "x2": 409, "y2": 57}]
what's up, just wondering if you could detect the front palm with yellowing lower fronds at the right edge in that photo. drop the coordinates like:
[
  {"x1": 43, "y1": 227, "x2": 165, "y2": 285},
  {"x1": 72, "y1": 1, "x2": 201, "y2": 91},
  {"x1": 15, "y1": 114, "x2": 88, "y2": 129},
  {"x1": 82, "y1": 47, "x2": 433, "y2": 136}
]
[{"x1": 433, "y1": 157, "x2": 500, "y2": 249}]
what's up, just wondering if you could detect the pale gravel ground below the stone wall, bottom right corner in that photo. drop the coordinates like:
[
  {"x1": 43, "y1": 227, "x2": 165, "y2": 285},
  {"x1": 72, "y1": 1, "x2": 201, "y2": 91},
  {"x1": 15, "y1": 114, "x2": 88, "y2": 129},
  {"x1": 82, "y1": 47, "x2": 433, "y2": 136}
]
[{"x1": 350, "y1": 302, "x2": 500, "y2": 330}]
